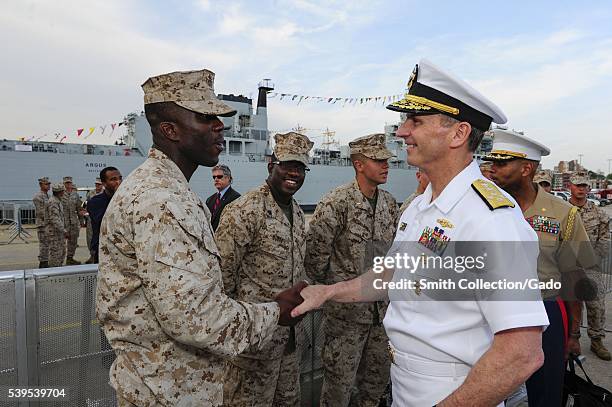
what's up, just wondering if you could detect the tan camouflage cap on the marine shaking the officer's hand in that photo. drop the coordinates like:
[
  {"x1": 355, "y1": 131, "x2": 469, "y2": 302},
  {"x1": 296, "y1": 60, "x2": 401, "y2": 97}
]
[{"x1": 142, "y1": 69, "x2": 236, "y2": 116}]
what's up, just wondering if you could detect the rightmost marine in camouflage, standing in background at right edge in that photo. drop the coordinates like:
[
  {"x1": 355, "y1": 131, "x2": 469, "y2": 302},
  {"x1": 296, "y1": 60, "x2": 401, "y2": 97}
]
[{"x1": 570, "y1": 174, "x2": 612, "y2": 360}]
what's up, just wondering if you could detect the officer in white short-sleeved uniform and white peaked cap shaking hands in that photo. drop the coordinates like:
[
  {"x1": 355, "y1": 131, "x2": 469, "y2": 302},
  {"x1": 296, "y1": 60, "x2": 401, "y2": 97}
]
[{"x1": 292, "y1": 60, "x2": 548, "y2": 407}]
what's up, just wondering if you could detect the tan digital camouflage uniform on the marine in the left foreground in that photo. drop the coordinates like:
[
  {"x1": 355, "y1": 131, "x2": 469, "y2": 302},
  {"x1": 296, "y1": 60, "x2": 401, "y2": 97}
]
[{"x1": 96, "y1": 149, "x2": 279, "y2": 407}]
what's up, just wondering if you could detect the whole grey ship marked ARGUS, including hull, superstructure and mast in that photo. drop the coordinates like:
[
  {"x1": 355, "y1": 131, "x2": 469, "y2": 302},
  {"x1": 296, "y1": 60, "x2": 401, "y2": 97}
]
[{"x1": 0, "y1": 79, "x2": 416, "y2": 208}]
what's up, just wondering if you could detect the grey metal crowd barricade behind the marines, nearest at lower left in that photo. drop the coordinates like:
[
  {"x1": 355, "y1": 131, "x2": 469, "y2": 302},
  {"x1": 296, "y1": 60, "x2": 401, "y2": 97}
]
[{"x1": 0, "y1": 265, "x2": 323, "y2": 407}]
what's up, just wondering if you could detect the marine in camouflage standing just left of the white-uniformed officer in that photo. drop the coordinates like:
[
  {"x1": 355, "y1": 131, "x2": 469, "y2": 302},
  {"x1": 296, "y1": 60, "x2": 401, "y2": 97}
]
[{"x1": 305, "y1": 134, "x2": 400, "y2": 407}]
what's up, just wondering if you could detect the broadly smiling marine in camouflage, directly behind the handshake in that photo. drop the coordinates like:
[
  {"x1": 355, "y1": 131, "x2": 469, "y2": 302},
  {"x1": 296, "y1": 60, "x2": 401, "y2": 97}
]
[{"x1": 215, "y1": 132, "x2": 313, "y2": 407}]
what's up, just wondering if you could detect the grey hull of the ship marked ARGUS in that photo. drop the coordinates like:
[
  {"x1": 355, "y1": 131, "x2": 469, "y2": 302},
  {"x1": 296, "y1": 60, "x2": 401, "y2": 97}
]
[{"x1": 0, "y1": 151, "x2": 416, "y2": 206}]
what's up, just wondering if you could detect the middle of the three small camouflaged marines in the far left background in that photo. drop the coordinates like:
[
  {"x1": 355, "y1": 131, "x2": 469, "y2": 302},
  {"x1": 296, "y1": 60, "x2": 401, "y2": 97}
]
[{"x1": 45, "y1": 184, "x2": 66, "y2": 267}]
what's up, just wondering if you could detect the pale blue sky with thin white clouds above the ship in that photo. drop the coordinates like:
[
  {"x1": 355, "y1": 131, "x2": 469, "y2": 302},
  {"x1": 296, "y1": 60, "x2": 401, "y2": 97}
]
[{"x1": 0, "y1": 0, "x2": 612, "y2": 173}]
